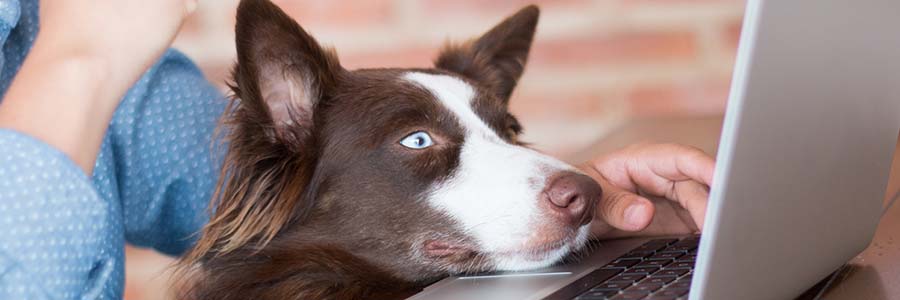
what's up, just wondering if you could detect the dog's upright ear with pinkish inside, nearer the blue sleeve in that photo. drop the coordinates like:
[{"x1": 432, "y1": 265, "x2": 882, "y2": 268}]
[{"x1": 233, "y1": 0, "x2": 343, "y2": 150}]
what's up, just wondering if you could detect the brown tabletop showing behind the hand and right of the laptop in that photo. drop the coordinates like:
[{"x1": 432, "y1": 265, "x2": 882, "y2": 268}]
[{"x1": 567, "y1": 117, "x2": 900, "y2": 299}]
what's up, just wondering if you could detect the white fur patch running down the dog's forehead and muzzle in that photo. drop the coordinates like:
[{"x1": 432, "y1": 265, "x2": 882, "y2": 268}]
[{"x1": 404, "y1": 72, "x2": 589, "y2": 270}]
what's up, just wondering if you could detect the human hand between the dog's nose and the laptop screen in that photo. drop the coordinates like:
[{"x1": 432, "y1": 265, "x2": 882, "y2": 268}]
[{"x1": 582, "y1": 144, "x2": 715, "y2": 239}]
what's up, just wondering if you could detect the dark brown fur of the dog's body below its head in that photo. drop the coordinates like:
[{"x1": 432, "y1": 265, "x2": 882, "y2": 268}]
[{"x1": 179, "y1": 241, "x2": 417, "y2": 300}]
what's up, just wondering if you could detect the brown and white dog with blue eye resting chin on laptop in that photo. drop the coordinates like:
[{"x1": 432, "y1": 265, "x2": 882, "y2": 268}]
[{"x1": 178, "y1": 0, "x2": 601, "y2": 299}]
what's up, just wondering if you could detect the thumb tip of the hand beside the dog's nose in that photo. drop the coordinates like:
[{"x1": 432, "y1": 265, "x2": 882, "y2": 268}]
[{"x1": 597, "y1": 186, "x2": 655, "y2": 231}]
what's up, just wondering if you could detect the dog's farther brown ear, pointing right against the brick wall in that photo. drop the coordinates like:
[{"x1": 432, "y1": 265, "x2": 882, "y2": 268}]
[{"x1": 435, "y1": 5, "x2": 540, "y2": 103}]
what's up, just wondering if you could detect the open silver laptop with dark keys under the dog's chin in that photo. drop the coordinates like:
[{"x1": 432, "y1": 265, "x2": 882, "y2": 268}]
[{"x1": 411, "y1": 0, "x2": 900, "y2": 300}]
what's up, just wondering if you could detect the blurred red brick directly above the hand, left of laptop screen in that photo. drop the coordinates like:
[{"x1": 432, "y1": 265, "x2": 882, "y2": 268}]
[{"x1": 627, "y1": 79, "x2": 729, "y2": 117}]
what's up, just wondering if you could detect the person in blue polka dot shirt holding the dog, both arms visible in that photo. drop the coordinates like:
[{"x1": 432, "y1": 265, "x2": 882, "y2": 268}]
[{"x1": 0, "y1": 0, "x2": 714, "y2": 299}]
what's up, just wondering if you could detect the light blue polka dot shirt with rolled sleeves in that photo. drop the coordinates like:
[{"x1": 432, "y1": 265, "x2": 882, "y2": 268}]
[{"x1": 0, "y1": 0, "x2": 226, "y2": 299}]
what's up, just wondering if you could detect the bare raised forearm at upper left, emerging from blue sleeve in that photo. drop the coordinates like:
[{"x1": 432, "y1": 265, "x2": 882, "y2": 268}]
[{"x1": 0, "y1": 0, "x2": 196, "y2": 174}]
